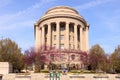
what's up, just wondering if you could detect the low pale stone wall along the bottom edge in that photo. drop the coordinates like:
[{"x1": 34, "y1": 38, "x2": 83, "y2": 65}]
[{"x1": 2, "y1": 73, "x2": 120, "y2": 80}]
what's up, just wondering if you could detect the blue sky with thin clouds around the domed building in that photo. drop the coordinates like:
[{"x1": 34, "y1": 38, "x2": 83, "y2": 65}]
[{"x1": 0, "y1": 0, "x2": 120, "y2": 53}]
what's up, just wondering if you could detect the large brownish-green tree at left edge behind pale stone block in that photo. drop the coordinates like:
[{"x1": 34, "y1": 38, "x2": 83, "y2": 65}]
[{"x1": 0, "y1": 38, "x2": 24, "y2": 71}]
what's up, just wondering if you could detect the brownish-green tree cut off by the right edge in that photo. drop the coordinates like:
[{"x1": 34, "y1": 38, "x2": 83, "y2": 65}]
[{"x1": 110, "y1": 46, "x2": 120, "y2": 73}]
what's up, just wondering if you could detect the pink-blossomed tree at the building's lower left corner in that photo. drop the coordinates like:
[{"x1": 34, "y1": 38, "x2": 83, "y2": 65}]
[{"x1": 24, "y1": 46, "x2": 53, "y2": 72}]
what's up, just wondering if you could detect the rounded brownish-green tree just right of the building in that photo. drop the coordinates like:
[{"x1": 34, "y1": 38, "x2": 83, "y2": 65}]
[{"x1": 89, "y1": 44, "x2": 107, "y2": 71}]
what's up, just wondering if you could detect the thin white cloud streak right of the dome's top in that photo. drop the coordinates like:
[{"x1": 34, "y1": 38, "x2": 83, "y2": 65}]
[{"x1": 75, "y1": 0, "x2": 114, "y2": 10}]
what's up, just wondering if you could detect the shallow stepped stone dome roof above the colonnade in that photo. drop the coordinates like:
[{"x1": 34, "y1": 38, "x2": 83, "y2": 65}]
[{"x1": 36, "y1": 6, "x2": 87, "y2": 24}]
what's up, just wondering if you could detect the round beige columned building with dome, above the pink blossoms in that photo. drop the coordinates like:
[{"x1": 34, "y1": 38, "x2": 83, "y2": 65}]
[{"x1": 34, "y1": 6, "x2": 89, "y2": 51}]
